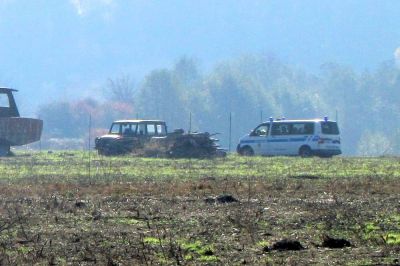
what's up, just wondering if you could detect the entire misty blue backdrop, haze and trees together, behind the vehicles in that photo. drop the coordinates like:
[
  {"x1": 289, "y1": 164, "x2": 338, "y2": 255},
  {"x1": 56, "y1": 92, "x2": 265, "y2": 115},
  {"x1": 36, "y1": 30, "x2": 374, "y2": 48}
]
[{"x1": 0, "y1": 0, "x2": 400, "y2": 155}]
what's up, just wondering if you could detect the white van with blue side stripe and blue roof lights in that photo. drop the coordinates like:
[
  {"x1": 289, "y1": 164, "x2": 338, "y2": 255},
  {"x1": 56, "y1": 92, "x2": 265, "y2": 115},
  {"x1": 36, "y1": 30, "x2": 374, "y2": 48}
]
[{"x1": 237, "y1": 117, "x2": 342, "y2": 157}]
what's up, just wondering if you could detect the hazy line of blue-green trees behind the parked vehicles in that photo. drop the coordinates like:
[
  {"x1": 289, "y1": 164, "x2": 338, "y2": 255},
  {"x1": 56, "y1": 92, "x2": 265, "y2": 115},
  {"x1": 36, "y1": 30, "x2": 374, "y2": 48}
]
[{"x1": 38, "y1": 55, "x2": 400, "y2": 155}]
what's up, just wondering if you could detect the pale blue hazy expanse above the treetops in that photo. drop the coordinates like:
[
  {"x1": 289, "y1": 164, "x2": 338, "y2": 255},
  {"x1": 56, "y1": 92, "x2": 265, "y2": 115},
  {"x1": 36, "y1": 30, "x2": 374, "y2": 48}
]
[{"x1": 0, "y1": 0, "x2": 400, "y2": 112}]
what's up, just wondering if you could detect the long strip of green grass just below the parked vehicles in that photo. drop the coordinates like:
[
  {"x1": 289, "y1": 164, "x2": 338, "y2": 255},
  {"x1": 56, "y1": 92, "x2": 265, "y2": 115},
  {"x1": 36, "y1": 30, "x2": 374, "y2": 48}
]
[{"x1": 4, "y1": 151, "x2": 400, "y2": 183}]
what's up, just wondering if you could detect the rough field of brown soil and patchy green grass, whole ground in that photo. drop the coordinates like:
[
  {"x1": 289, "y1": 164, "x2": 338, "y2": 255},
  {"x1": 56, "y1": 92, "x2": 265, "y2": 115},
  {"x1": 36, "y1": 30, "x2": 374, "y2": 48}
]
[{"x1": 0, "y1": 152, "x2": 400, "y2": 265}]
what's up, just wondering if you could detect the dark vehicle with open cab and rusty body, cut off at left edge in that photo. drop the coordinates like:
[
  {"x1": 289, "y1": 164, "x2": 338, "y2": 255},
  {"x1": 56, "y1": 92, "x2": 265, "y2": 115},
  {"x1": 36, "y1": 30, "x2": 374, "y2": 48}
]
[{"x1": 0, "y1": 88, "x2": 43, "y2": 156}]
